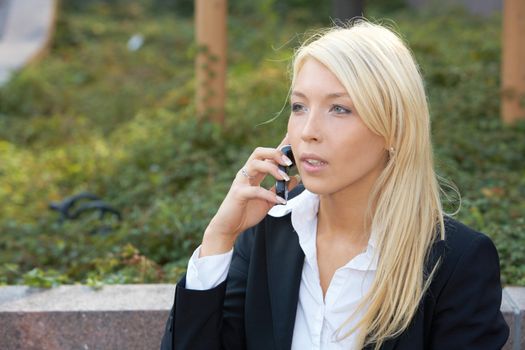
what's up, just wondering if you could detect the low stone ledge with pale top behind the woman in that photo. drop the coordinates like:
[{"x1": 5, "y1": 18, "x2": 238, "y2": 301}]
[{"x1": 0, "y1": 284, "x2": 525, "y2": 350}]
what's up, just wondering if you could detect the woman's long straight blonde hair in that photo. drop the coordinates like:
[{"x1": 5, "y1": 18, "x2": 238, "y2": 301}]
[{"x1": 292, "y1": 20, "x2": 445, "y2": 349}]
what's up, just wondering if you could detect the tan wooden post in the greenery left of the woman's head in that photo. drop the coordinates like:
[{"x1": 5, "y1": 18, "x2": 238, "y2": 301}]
[{"x1": 195, "y1": 0, "x2": 227, "y2": 124}]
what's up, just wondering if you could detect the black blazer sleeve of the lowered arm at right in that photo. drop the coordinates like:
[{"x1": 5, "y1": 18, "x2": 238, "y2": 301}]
[{"x1": 430, "y1": 235, "x2": 509, "y2": 350}]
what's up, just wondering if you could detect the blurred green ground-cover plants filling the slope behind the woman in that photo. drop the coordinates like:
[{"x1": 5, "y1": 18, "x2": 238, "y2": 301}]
[{"x1": 0, "y1": 0, "x2": 525, "y2": 287}]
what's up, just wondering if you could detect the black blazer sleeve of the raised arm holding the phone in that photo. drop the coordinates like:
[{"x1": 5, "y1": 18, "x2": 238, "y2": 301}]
[{"x1": 161, "y1": 228, "x2": 255, "y2": 350}]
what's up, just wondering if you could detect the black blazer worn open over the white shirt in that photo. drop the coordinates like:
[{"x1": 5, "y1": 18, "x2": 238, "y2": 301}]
[{"x1": 161, "y1": 189, "x2": 509, "y2": 350}]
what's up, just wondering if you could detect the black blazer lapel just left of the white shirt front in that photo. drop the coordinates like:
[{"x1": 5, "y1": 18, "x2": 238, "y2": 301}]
[{"x1": 266, "y1": 215, "x2": 304, "y2": 350}]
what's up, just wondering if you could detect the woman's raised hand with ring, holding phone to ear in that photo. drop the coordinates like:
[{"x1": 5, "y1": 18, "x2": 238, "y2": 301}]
[{"x1": 200, "y1": 138, "x2": 298, "y2": 257}]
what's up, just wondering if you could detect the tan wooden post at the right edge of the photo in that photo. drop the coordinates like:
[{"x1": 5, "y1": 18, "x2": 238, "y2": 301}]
[{"x1": 501, "y1": 0, "x2": 525, "y2": 124}]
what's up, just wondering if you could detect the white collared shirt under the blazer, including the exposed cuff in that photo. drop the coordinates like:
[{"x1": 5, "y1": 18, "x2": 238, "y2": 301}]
[{"x1": 186, "y1": 190, "x2": 377, "y2": 350}]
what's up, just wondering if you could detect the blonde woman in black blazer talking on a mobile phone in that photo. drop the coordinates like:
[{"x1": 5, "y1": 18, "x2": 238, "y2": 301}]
[{"x1": 162, "y1": 21, "x2": 508, "y2": 350}]
